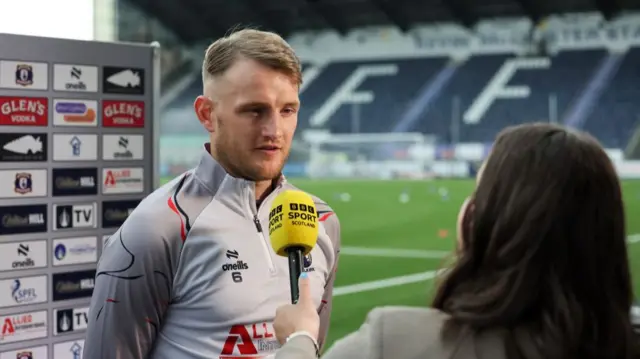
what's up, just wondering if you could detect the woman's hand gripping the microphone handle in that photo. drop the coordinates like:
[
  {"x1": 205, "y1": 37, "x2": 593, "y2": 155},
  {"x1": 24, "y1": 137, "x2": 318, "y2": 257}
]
[{"x1": 273, "y1": 273, "x2": 320, "y2": 344}]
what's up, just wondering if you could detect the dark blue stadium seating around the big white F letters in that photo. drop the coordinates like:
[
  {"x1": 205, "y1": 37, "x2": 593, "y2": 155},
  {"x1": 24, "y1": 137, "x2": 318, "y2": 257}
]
[{"x1": 162, "y1": 49, "x2": 640, "y2": 148}]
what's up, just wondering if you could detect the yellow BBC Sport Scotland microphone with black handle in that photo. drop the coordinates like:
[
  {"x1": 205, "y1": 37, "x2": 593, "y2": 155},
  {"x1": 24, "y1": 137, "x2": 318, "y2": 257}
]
[{"x1": 269, "y1": 190, "x2": 318, "y2": 304}]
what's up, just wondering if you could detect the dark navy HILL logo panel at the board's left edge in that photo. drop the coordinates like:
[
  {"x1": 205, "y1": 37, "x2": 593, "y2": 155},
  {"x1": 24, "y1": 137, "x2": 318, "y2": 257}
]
[{"x1": 0, "y1": 204, "x2": 47, "y2": 235}]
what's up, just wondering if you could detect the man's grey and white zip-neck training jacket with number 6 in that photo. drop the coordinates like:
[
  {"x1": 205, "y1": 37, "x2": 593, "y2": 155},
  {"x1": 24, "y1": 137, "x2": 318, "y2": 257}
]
[{"x1": 83, "y1": 144, "x2": 340, "y2": 359}]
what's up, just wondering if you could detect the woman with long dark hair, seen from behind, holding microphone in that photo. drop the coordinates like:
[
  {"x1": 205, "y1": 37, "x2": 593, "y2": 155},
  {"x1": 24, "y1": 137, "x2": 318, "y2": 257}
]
[{"x1": 275, "y1": 124, "x2": 640, "y2": 359}]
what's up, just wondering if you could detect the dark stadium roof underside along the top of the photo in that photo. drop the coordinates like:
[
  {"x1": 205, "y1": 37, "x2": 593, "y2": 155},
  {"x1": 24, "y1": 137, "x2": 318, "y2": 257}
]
[{"x1": 130, "y1": 0, "x2": 640, "y2": 43}]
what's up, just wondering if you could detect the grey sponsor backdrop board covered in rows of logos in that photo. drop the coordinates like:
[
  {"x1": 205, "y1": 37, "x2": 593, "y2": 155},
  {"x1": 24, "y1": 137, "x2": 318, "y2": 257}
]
[{"x1": 0, "y1": 34, "x2": 160, "y2": 359}]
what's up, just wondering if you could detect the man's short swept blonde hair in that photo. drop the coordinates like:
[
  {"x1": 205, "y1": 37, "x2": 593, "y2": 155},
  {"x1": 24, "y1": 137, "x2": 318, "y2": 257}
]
[{"x1": 202, "y1": 29, "x2": 302, "y2": 86}]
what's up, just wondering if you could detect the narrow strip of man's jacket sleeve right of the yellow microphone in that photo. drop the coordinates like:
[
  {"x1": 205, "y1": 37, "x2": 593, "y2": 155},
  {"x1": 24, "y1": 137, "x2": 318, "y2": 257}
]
[{"x1": 318, "y1": 212, "x2": 341, "y2": 350}]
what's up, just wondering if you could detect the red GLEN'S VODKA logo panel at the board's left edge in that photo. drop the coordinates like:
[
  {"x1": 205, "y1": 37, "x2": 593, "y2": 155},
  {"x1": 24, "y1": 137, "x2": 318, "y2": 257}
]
[{"x1": 0, "y1": 97, "x2": 49, "y2": 126}]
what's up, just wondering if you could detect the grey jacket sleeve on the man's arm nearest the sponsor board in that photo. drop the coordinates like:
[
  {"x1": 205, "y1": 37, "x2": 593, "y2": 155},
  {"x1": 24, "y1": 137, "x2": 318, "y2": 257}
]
[{"x1": 83, "y1": 212, "x2": 179, "y2": 359}]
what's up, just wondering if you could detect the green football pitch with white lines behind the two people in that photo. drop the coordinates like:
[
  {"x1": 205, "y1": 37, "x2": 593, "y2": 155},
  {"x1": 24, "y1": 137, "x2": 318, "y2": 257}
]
[{"x1": 159, "y1": 179, "x2": 640, "y2": 345}]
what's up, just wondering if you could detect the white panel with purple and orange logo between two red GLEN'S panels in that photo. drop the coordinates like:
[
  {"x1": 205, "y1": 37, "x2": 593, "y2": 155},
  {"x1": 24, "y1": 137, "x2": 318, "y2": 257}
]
[{"x1": 53, "y1": 99, "x2": 98, "y2": 127}]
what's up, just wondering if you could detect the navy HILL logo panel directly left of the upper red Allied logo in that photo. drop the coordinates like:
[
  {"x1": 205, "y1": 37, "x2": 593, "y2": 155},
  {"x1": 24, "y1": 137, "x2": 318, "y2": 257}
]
[{"x1": 51, "y1": 167, "x2": 98, "y2": 196}]
